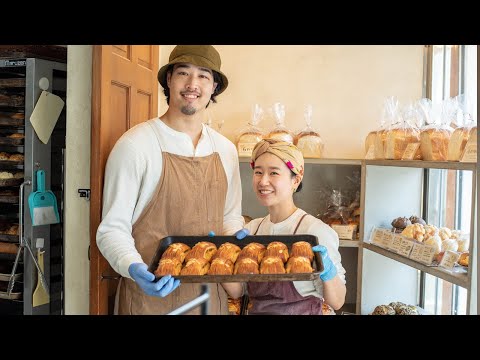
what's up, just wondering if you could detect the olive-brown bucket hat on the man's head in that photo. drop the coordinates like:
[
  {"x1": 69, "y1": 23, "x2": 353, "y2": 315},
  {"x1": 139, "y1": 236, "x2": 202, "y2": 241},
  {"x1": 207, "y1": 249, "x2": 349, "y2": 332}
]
[{"x1": 157, "y1": 45, "x2": 228, "y2": 94}]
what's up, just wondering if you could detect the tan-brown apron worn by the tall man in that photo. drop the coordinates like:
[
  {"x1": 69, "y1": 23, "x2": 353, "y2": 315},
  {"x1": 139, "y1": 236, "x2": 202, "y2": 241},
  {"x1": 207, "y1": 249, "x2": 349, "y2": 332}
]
[{"x1": 116, "y1": 121, "x2": 228, "y2": 315}]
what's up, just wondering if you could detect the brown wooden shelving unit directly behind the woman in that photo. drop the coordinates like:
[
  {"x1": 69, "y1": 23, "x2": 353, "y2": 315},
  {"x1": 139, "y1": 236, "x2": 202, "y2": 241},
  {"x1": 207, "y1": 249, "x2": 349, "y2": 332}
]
[{"x1": 240, "y1": 157, "x2": 363, "y2": 313}]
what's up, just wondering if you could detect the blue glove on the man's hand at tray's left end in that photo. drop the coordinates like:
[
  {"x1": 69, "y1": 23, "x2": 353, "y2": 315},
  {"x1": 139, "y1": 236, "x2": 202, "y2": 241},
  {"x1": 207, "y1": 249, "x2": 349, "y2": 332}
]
[{"x1": 128, "y1": 263, "x2": 180, "y2": 297}]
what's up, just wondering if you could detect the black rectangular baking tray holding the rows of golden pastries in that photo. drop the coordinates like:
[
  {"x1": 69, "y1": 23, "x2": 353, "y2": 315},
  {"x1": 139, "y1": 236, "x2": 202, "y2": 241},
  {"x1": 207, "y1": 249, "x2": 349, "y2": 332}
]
[{"x1": 148, "y1": 235, "x2": 323, "y2": 283}]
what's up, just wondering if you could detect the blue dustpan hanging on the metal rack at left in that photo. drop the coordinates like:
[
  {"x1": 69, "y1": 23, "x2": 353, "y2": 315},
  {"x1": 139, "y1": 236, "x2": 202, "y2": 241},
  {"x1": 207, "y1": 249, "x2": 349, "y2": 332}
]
[{"x1": 28, "y1": 170, "x2": 60, "y2": 226}]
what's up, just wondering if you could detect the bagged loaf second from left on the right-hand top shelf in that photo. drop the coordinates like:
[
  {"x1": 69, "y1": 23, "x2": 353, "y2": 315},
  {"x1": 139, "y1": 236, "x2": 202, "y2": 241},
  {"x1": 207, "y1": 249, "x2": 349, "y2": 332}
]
[{"x1": 384, "y1": 127, "x2": 422, "y2": 160}]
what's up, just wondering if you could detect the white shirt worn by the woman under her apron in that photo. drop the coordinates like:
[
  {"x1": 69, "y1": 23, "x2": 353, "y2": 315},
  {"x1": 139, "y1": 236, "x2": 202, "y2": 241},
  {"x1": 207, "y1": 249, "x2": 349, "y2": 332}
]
[{"x1": 245, "y1": 209, "x2": 345, "y2": 297}]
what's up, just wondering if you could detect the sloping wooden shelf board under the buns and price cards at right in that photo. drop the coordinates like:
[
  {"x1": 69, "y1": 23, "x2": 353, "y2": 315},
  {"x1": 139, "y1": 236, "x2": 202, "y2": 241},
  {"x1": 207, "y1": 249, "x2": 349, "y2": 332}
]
[{"x1": 362, "y1": 242, "x2": 468, "y2": 288}]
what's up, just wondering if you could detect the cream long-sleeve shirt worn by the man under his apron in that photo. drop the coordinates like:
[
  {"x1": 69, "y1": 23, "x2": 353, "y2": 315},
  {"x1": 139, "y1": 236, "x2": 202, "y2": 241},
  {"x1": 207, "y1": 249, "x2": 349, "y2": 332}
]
[{"x1": 97, "y1": 118, "x2": 244, "y2": 278}]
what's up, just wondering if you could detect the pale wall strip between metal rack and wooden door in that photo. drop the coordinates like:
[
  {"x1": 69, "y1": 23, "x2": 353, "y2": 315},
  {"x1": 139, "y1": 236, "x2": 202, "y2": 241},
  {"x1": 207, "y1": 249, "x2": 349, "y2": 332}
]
[{"x1": 64, "y1": 45, "x2": 92, "y2": 315}]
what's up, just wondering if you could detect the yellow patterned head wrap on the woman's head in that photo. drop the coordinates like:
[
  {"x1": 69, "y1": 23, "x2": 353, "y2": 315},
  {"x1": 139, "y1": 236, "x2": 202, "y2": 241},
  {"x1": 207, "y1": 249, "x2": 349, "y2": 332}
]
[{"x1": 250, "y1": 139, "x2": 305, "y2": 177}]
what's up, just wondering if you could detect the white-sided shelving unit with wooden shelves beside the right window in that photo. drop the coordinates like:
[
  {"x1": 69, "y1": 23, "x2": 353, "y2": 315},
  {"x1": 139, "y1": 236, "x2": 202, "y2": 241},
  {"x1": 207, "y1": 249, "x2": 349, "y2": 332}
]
[{"x1": 357, "y1": 160, "x2": 478, "y2": 314}]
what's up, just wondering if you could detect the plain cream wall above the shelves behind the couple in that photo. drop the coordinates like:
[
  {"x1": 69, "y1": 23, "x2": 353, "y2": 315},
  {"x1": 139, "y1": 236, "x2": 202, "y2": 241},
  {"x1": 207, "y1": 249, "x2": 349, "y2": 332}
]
[{"x1": 159, "y1": 45, "x2": 423, "y2": 159}]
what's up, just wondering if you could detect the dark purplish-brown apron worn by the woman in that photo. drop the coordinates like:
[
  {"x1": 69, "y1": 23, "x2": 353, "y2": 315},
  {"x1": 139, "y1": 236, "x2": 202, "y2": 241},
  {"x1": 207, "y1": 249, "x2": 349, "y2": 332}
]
[{"x1": 247, "y1": 214, "x2": 323, "y2": 315}]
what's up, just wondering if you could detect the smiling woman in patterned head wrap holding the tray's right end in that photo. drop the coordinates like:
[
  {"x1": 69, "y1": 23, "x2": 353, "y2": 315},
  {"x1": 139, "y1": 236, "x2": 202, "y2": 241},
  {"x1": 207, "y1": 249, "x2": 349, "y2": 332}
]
[{"x1": 223, "y1": 139, "x2": 346, "y2": 315}]
